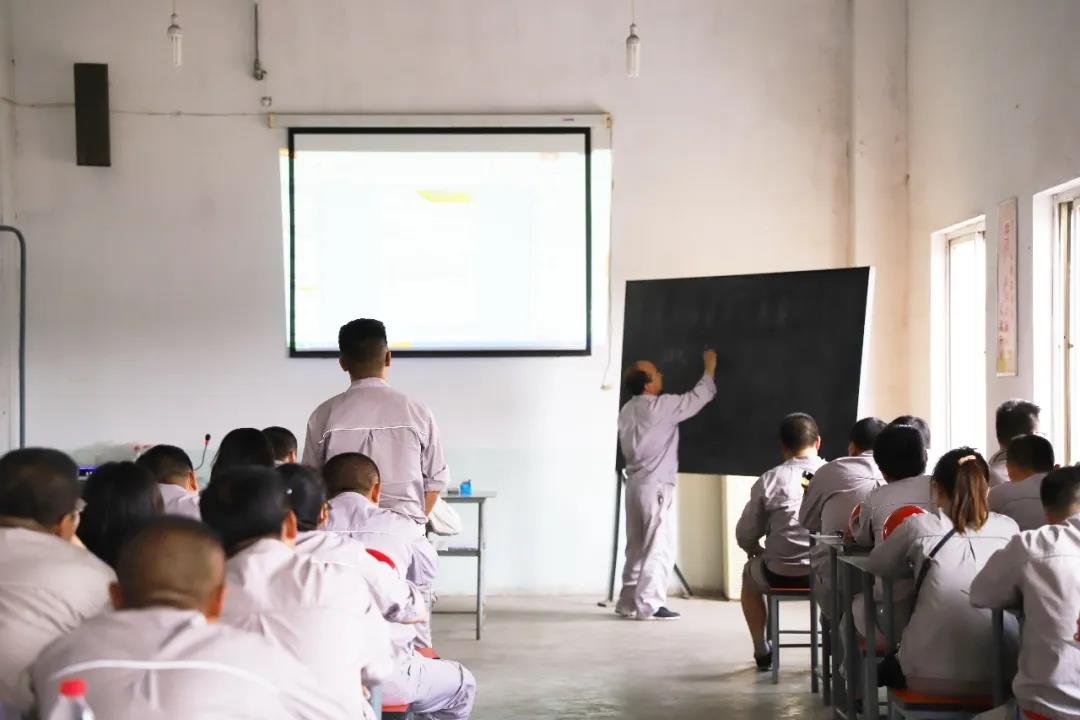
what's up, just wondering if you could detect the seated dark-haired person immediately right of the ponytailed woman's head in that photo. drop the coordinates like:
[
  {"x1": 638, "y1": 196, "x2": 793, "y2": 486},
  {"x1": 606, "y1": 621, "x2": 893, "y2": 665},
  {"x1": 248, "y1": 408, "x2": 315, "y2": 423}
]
[{"x1": 990, "y1": 435, "x2": 1054, "y2": 530}]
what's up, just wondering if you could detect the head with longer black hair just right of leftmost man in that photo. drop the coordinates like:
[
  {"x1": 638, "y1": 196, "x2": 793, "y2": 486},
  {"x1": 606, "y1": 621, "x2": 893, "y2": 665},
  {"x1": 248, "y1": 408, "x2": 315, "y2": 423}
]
[{"x1": 78, "y1": 462, "x2": 165, "y2": 570}]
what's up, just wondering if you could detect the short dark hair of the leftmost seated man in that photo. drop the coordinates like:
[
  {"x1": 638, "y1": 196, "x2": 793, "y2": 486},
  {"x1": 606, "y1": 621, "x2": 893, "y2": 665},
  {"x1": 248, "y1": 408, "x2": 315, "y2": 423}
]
[{"x1": 0, "y1": 448, "x2": 80, "y2": 528}]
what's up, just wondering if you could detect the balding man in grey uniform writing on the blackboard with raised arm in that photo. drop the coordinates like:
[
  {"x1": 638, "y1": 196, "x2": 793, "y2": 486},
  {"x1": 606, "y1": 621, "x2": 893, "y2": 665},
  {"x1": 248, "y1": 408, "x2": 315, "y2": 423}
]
[{"x1": 615, "y1": 350, "x2": 716, "y2": 620}]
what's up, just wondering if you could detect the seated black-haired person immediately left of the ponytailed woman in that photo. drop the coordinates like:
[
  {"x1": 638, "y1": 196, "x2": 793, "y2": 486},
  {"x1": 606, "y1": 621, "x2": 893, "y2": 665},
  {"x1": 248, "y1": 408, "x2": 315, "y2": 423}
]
[{"x1": 851, "y1": 421, "x2": 934, "y2": 547}]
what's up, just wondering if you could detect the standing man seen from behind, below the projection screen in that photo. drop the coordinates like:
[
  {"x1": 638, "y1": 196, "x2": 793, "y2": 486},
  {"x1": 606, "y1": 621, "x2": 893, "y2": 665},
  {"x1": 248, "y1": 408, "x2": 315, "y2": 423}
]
[{"x1": 303, "y1": 320, "x2": 450, "y2": 525}]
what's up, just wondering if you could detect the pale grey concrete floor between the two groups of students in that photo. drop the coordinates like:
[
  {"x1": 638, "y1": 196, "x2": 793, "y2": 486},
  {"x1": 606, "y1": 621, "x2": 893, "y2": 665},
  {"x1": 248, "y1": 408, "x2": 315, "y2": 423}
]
[{"x1": 435, "y1": 597, "x2": 831, "y2": 720}]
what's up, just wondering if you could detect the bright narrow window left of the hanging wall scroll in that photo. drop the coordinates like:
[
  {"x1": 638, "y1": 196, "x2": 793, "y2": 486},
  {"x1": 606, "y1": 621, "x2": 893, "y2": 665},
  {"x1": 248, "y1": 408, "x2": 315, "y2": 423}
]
[{"x1": 944, "y1": 223, "x2": 986, "y2": 448}]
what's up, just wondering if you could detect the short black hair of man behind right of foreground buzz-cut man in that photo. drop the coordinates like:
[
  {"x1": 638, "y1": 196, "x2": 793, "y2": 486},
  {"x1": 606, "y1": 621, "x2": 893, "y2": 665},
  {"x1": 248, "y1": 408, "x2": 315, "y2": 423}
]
[{"x1": 199, "y1": 465, "x2": 292, "y2": 555}]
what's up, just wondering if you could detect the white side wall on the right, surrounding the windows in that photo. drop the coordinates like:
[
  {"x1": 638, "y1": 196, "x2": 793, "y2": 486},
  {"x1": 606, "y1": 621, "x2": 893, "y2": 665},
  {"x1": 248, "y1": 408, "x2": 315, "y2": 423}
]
[{"x1": 908, "y1": 0, "x2": 1080, "y2": 449}]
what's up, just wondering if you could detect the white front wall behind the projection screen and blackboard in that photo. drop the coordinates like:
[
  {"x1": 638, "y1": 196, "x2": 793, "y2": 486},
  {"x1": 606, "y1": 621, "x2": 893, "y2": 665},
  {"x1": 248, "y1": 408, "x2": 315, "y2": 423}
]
[{"x1": 13, "y1": 0, "x2": 902, "y2": 593}]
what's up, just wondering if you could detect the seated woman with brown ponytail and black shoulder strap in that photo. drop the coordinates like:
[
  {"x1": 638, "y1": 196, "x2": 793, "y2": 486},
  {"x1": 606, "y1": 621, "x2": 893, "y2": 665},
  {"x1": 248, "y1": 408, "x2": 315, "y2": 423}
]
[{"x1": 868, "y1": 448, "x2": 1020, "y2": 696}]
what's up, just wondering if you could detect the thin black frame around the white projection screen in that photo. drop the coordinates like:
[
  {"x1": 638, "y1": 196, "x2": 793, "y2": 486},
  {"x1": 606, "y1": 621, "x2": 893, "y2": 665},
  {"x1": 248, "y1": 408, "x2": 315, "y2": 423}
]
[{"x1": 286, "y1": 125, "x2": 593, "y2": 358}]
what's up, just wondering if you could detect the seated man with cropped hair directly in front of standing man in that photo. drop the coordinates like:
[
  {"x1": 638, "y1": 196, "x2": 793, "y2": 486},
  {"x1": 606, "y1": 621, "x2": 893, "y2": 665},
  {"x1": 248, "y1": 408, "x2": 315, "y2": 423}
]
[{"x1": 323, "y1": 452, "x2": 438, "y2": 648}]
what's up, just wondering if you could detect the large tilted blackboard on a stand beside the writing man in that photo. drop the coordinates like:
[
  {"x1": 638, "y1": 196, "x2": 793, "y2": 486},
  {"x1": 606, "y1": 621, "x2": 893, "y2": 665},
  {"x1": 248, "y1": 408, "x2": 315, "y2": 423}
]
[{"x1": 617, "y1": 268, "x2": 870, "y2": 476}]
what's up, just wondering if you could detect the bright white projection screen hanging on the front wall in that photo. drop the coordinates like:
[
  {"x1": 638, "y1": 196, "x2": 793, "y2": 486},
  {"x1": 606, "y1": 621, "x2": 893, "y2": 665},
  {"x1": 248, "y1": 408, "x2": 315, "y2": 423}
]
[{"x1": 286, "y1": 126, "x2": 591, "y2": 356}]
